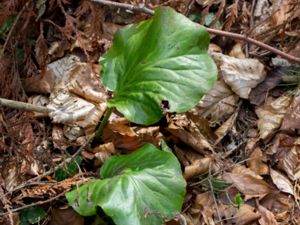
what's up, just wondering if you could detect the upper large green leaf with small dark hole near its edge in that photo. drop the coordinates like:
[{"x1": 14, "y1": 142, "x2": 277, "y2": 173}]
[{"x1": 100, "y1": 8, "x2": 217, "y2": 125}]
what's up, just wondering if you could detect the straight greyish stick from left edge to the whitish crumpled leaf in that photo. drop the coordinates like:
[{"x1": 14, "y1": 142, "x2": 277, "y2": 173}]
[{"x1": 0, "y1": 98, "x2": 52, "y2": 113}]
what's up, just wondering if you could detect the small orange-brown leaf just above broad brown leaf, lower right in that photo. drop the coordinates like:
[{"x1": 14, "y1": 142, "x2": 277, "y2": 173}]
[{"x1": 247, "y1": 148, "x2": 269, "y2": 175}]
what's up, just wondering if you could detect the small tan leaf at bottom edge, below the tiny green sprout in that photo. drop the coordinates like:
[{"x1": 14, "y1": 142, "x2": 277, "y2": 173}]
[{"x1": 234, "y1": 204, "x2": 260, "y2": 225}]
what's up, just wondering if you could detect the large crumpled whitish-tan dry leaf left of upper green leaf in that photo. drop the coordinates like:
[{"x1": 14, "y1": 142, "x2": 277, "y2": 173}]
[{"x1": 46, "y1": 55, "x2": 106, "y2": 139}]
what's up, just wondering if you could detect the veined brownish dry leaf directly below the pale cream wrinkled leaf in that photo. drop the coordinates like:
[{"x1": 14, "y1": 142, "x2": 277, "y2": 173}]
[{"x1": 193, "y1": 80, "x2": 239, "y2": 124}]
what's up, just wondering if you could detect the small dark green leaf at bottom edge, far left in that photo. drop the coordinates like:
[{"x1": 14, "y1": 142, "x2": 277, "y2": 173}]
[{"x1": 20, "y1": 207, "x2": 47, "y2": 225}]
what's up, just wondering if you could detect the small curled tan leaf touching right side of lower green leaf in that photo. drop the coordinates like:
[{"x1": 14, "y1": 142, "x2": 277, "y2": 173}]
[{"x1": 183, "y1": 158, "x2": 211, "y2": 180}]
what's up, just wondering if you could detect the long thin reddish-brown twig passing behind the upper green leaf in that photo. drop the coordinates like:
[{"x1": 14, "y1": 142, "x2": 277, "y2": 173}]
[{"x1": 92, "y1": 0, "x2": 300, "y2": 64}]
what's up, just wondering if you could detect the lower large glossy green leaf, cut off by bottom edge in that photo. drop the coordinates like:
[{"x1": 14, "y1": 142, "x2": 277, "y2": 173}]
[{"x1": 66, "y1": 144, "x2": 186, "y2": 225}]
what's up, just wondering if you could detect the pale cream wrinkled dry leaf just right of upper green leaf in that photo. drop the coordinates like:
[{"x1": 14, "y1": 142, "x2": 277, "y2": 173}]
[{"x1": 211, "y1": 53, "x2": 266, "y2": 99}]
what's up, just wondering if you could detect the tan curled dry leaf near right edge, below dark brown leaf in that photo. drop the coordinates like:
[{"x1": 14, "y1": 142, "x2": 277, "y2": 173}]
[{"x1": 255, "y1": 95, "x2": 292, "y2": 139}]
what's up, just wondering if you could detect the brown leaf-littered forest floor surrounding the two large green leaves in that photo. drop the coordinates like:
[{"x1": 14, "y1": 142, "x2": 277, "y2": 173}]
[{"x1": 0, "y1": 0, "x2": 300, "y2": 225}]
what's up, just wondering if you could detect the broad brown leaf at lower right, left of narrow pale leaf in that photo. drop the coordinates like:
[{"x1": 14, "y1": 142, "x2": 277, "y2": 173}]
[{"x1": 223, "y1": 173, "x2": 271, "y2": 200}]
